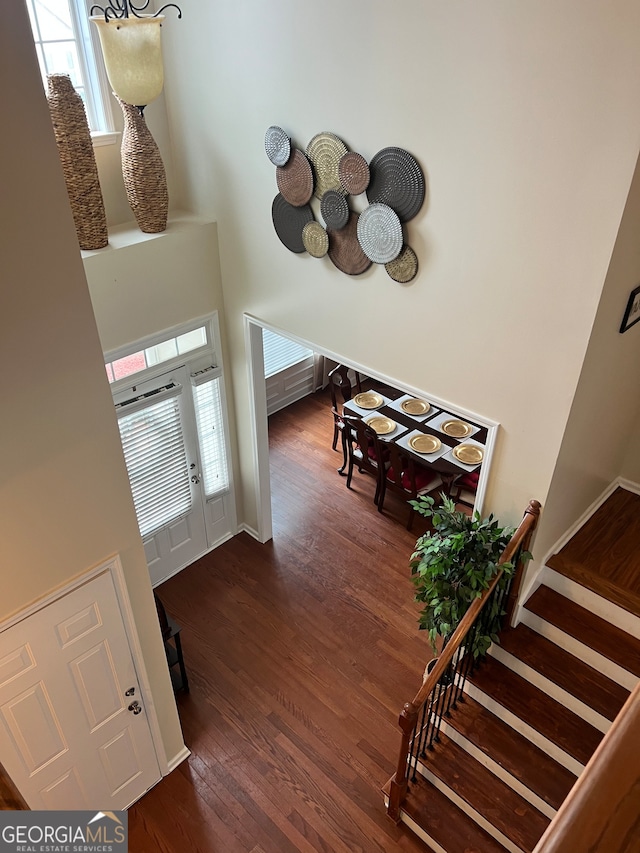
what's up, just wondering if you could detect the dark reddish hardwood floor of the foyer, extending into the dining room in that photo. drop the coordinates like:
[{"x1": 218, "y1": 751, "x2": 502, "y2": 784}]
[{"x1": 129, "y1": 388, "x2": 430, "y2": 853}]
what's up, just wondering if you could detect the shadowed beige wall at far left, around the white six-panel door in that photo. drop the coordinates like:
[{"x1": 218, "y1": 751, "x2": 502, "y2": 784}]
[{"x1": 0, "y1": 2, "x2": 182, "y2": 772}]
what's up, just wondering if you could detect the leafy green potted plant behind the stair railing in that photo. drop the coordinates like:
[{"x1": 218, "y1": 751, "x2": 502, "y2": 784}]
[{"x1": 409, "y1": 495, "x2": 529, "y2": 657}]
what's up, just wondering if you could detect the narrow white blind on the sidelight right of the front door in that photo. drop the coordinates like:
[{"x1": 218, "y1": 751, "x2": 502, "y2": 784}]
[{"x1": 192, "y1": 372, "x2": 229, "y2": 497}]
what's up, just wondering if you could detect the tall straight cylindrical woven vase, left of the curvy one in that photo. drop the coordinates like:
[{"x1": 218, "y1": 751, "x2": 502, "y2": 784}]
[{"x1": 47, "y1": 74, "x2": 109, "y2": 249}]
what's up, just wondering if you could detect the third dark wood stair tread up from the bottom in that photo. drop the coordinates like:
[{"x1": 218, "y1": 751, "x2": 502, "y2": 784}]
[{"x1": 446, "y1": 696, "x2": 576, "y2": 809}]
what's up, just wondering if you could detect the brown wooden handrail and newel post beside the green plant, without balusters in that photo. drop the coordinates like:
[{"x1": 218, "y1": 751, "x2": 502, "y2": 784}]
[{"x1": 387, "y1": 500, "x2": 540, "y2": 823}]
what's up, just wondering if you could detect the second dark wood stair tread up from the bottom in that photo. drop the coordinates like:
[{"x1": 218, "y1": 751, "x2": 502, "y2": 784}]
[{"x1": 423, "y1": 732, "x2": 549, "y2": 850}]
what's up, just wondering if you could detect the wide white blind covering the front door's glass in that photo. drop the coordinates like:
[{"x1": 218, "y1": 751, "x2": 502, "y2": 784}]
[{"x1": 118, "y1": 386, "x2": 191, "y2": 537}]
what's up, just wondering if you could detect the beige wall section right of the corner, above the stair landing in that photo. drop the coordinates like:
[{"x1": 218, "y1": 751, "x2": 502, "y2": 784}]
[{"x1": 537, "y1": 148, "x2": 640, "y2": 556}]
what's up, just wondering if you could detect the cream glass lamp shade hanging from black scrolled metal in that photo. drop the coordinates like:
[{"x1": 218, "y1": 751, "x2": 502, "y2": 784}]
[{"x1": 91, "y1": 15, "x2": 164, "y2": 107}]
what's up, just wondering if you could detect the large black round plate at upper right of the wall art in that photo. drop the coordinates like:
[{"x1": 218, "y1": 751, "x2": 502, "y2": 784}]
[{"x1": 367, "y1": 148, "x2": 425, "y2": 222}]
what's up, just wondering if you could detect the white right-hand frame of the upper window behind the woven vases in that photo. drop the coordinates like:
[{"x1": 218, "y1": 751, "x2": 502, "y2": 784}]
[{"x1": 28, "y1": 0, "x2": 118, "y2": 140}]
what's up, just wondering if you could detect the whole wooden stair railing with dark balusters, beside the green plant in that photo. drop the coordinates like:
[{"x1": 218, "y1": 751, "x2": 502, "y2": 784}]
[{"x1": 387, "y1": 500, "x2": 540, "y2": 823}]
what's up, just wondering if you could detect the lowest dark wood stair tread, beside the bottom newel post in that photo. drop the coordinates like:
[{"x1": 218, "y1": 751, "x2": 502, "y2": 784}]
[{"x1": 390, "y1": 775, "x2": 506, "y2": 853}]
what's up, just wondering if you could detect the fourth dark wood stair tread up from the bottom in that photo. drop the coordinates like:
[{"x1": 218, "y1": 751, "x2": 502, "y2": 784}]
[{"x1": 468, "y1": 655, "x2": 603, "y2": 764}]
